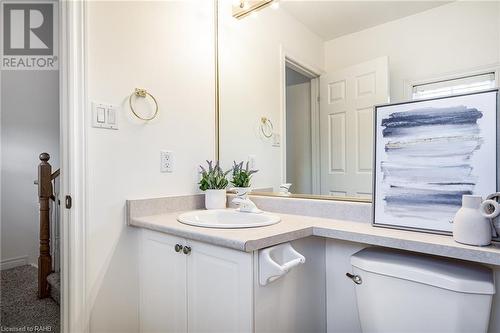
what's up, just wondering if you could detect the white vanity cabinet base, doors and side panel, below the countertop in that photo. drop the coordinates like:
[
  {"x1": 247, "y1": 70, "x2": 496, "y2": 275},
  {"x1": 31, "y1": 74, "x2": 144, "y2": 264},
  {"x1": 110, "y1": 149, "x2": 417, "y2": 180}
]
[{"x1": 139, "y1": 230, "x2": 326, "y2": 332}]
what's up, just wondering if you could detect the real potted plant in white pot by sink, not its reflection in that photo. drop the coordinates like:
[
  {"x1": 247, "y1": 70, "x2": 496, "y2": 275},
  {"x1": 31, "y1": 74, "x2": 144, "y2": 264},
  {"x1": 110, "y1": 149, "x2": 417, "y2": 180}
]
[{"x1": 198, "y1": 161, "x2": 231, "y2": 209}]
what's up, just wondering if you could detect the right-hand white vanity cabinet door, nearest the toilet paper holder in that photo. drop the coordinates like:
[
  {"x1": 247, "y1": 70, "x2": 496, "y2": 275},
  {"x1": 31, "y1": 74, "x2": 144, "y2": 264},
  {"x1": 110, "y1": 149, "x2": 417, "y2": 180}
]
[{"x1": 187, "y1": 241, "x2": 253, "y2": 333}]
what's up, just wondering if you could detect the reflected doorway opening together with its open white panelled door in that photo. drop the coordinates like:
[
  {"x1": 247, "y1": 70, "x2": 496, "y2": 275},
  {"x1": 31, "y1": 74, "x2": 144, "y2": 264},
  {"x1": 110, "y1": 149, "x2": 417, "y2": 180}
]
[{"x1": 272, "y1": 57, "x2": 389, "y2": 199}]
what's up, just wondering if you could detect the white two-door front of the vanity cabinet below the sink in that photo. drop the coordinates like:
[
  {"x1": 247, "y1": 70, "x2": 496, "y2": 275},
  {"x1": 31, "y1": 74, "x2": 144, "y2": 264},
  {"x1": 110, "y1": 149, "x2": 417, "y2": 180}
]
[{"x1": 139, "y1": 230, "x2": 253, "y2": 333}]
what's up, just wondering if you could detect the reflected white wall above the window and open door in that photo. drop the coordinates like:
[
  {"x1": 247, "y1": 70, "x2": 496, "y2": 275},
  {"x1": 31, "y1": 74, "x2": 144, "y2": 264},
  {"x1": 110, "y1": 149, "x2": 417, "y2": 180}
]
[{"x1": 325, "y1": 1, "x2": 500, "y2": 102}]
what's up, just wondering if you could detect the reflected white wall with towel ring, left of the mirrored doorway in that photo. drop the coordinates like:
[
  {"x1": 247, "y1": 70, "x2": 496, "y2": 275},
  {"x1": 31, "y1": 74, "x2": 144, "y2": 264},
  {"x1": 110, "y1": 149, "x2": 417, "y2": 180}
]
[{"x1": 219, "y1": 0, "x2": 324, "y2": 191}]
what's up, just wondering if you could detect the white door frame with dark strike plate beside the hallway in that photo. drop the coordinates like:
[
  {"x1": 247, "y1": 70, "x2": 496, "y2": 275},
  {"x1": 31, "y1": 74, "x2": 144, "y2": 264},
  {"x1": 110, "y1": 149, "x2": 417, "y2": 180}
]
[{"x1": 59, "y1": 0, "x2": 89, "y2": 332}]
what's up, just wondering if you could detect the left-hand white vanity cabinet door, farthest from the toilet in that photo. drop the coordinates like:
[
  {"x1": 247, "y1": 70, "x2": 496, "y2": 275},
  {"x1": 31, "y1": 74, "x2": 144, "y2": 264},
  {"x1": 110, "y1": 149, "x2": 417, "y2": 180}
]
[{"x1": 139, "y1": 230, "x2": 187, "y2": 333}]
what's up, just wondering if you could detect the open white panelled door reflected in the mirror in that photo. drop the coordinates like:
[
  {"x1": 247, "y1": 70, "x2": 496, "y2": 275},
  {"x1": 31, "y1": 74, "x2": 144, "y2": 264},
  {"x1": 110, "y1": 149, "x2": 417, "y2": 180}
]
[{"x1": 320, "y1": 57, "x2": 389, "y2": 198}]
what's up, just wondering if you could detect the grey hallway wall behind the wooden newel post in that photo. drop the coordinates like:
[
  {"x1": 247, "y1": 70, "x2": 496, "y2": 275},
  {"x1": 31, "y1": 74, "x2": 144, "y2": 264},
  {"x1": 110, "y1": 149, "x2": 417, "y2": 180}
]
[{"x1": 0, "y1": 71, "x2": 59, "y2": 268}]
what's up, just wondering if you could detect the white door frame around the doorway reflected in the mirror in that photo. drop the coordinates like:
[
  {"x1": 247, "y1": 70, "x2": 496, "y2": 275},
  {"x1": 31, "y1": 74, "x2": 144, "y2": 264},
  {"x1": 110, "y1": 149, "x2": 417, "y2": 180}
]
[{"x1": 280, "y1": 45, "x2": 324, "y2": 193}]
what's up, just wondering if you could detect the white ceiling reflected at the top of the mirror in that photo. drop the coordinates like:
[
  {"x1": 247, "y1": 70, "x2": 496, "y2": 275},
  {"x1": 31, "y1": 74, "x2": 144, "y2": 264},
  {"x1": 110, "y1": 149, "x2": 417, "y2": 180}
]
[{"x1": 280, "y1": 0, "x2": 451, "y2": 40}]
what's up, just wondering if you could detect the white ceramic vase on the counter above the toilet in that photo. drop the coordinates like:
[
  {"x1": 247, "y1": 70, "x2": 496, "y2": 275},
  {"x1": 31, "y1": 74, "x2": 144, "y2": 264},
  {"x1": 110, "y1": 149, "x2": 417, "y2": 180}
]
[{"x1": 453, "y1": 195, "x2": 491, "y2": 246}]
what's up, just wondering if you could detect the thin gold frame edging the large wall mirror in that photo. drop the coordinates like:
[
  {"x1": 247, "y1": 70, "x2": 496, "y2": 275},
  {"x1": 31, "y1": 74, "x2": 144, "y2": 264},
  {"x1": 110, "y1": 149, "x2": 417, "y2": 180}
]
[{"x1": 214, "y1": 0, "x2": 373, "y2": 204}]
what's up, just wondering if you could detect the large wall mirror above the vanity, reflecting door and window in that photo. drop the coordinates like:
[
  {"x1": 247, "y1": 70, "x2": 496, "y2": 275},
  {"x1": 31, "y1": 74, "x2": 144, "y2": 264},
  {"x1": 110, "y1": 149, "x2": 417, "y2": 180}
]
[{"x1": 218, "y1": 0, "x2": 500, "y2": 201}]
